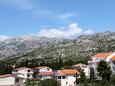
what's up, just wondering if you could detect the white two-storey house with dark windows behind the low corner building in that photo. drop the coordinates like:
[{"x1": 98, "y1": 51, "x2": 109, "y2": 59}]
[{"x1": 12, "y1": 67, "x2": 34, "y2": 82}]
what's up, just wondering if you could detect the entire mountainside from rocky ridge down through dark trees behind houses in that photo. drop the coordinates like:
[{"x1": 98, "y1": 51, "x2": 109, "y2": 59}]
[{"x1": 0, "y1": 32, "x2": 115, "y2": 73}]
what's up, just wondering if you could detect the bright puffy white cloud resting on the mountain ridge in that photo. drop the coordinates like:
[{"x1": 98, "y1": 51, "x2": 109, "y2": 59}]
[{"x1": 38, "y1": 23, "x2": 83, "y2": 38}]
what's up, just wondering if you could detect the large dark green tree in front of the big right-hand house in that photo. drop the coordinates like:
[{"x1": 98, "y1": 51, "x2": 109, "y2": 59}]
[{"x1": 97, "y1": 60, "x2": 112, "y2": 81}]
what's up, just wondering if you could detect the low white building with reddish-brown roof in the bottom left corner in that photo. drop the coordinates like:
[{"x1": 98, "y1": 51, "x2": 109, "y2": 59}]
[{"x1": 0, "y1": 74, "x2": 24, "y2": 86}]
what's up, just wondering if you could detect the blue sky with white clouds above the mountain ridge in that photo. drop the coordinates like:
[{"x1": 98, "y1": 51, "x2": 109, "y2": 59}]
[{"x1": 0, "y1": 0, "x2": 115, "y2": 39}]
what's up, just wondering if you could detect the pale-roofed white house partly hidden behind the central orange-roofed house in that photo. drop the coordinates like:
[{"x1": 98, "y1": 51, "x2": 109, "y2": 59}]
[{"x1": 71, "y1": 63, "x2": 90, "y2": 78}]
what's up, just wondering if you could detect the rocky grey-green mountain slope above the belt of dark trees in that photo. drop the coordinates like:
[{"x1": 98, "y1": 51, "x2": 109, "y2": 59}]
[{"x1": 0, "y1": 32, "x2": 115, "y2": 62}]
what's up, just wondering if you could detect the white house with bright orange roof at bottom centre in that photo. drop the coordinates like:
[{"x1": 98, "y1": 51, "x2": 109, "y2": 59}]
[{"x1": 55, "y1": 69, "x2": 79, "y2": 86}]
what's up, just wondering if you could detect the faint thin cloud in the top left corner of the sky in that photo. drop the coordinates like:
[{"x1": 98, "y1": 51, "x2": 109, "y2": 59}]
[{"x1": 0, "y1": 0, "x2": 33, "y2": 10}]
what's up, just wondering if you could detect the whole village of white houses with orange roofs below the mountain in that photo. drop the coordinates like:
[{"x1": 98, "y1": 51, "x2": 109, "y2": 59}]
[{"x1": 0, "y1": 52, "x2": 115, "y2": 86}]
